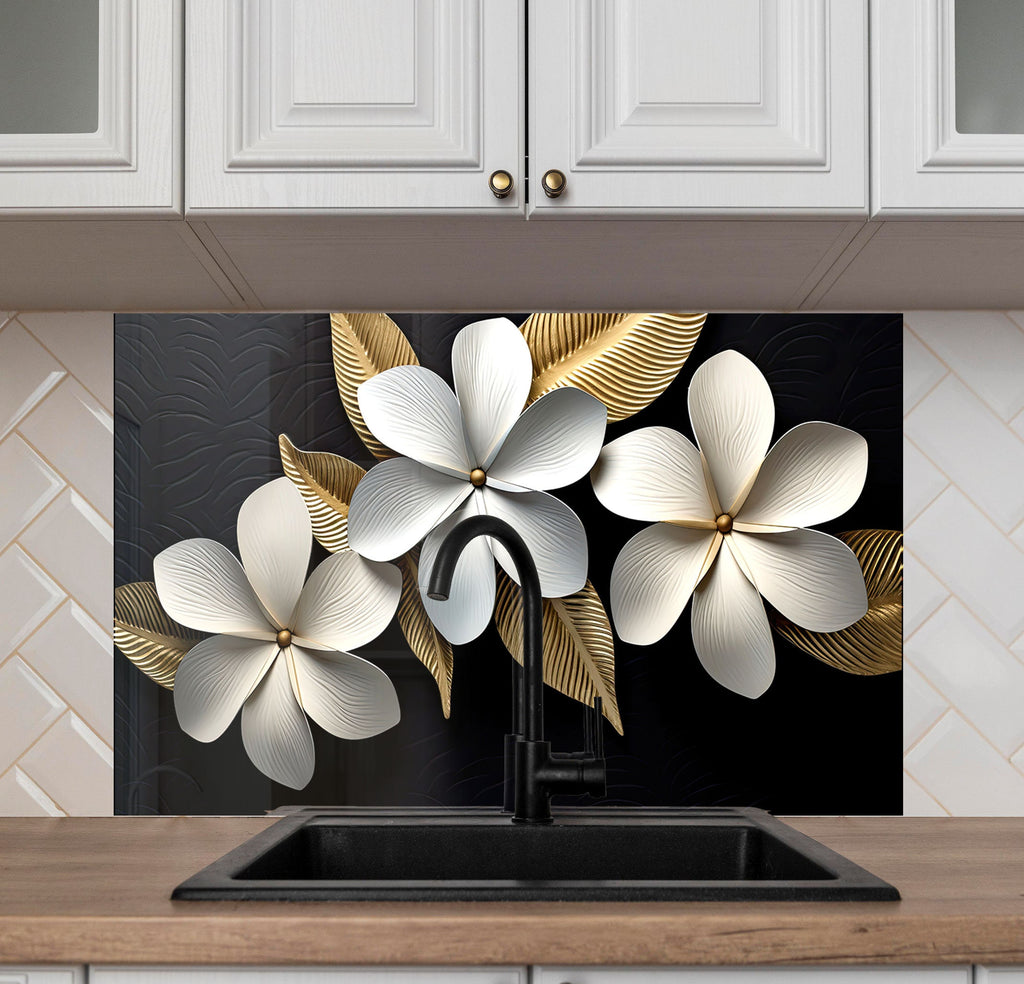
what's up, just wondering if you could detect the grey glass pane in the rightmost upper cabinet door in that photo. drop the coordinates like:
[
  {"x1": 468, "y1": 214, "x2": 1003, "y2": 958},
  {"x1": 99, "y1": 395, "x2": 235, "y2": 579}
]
[{"x1": 955, "y1": 0, "x2": 1024, "y2": 133}]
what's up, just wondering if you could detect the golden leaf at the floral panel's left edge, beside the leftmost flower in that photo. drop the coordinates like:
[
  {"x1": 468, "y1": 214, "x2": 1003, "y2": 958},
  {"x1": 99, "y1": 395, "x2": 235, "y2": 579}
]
[{"x1": 114, "y1": 581, "x2": 206, "y2": 690}]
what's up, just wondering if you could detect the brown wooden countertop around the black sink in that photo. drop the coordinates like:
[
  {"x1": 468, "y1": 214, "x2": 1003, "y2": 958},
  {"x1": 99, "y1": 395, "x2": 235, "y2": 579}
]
[{"x1": 0, "y1": 817, "x2": 1024, "y2": 965}]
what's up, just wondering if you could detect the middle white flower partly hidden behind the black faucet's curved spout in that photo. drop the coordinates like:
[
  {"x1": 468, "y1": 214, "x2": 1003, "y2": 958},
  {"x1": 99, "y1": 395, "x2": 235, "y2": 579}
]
[{"x1": 348, "y1": 317, "x2": 607, "y2": 643}]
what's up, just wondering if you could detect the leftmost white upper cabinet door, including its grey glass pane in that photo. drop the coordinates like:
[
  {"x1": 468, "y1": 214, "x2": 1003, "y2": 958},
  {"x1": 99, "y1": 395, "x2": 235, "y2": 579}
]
[{"x1": 0, "y1": 0, "x2": 181, "y2": 217}]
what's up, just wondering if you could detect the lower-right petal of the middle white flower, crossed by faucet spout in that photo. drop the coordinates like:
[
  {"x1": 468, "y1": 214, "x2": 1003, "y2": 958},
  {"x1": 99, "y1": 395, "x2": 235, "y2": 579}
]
[{"x1": 482, "y1": 488, "x2": 587, "y2": 598}]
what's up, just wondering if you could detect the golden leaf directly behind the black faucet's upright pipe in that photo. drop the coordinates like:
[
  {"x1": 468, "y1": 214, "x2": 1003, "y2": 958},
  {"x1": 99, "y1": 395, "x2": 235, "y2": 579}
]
[{"x1": 495, "y1": 570, "x2": 623, "y2": 734}]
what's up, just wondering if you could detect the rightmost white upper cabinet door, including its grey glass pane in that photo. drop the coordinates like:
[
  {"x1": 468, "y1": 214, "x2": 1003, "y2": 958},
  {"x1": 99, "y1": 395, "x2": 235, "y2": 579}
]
[{"x1": 871, "y1": 0, "x2": 1024, "y2": 216}]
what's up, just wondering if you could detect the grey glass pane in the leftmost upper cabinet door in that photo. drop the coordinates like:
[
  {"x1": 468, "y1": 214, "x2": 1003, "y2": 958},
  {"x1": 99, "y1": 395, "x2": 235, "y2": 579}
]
[{"x1": 0, "y1": 0, "x2": 99, "y2": 133}]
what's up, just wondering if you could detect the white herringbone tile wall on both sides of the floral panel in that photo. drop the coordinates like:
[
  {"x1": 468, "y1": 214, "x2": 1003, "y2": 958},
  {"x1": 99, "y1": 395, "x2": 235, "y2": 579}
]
[{"x1": 0, "y1": 311, "x2": 1024, "y2": 815}]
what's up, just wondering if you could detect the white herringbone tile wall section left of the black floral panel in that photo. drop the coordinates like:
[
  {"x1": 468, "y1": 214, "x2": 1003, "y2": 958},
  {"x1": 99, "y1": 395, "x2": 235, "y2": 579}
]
[{"x1": 0, "y1": 312, "x2": 114, "y2": 816}]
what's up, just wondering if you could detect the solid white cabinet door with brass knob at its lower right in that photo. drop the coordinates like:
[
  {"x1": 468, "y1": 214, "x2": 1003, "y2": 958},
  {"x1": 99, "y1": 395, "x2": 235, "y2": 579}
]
[{"x1": 186, "y1": 0, "x2": 523, "y2": 215}]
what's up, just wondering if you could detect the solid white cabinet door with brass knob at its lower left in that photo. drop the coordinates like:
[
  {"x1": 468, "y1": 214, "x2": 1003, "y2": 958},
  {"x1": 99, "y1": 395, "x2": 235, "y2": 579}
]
[{"x1": 529, "y1": 0, "x2": 867, "y2": 217}]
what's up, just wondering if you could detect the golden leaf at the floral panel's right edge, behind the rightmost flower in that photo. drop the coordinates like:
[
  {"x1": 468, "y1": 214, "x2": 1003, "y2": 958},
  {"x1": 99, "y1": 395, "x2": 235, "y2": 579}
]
[{"x1": 772, "y1": 529, "x2": 903, "y2": 677}]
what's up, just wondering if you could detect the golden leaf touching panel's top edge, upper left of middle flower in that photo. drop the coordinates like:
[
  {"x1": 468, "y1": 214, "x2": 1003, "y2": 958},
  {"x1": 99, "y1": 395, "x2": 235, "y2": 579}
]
[{"x1": 331, "y1": 312, "x2": 420, "y2": 458}]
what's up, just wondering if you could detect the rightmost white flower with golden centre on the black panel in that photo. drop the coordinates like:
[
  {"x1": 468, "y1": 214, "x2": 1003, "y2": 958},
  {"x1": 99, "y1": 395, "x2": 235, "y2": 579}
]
[{"x1": 592, "y1": 351, "x2": 867, "y2": 697}]
